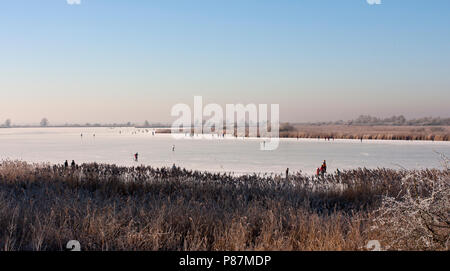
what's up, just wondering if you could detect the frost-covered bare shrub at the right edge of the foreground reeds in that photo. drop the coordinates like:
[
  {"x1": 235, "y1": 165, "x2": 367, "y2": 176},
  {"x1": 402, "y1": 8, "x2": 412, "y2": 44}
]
[{"x1": 372, "y1": 156, "x2": 450, "y2": 250}]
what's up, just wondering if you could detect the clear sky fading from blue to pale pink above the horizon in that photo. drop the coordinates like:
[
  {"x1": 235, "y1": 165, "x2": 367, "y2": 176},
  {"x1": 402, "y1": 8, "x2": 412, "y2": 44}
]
[{"x1": 0, "y1": 0, "x2": 450, "y2": 124}]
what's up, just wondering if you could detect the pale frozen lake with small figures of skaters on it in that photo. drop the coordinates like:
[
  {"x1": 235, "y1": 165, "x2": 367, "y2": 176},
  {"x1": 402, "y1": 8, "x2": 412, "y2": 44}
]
[{"x1": 0, "y1": 128, "x2": 450, "y2": 174}]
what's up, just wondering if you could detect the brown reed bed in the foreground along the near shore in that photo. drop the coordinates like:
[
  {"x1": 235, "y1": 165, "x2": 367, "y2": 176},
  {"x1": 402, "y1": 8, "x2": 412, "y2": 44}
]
[{"x1": 0, "y1": 161, "x2": 450, "y2": 251}]
